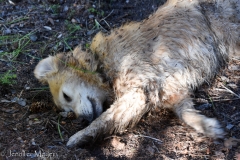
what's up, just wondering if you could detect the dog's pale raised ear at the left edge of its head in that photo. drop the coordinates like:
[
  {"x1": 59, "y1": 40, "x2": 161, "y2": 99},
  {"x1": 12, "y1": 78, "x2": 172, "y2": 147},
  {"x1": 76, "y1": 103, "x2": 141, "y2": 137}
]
[{"x1": 34, "y1": 56, "x2": 57, "y2": 83}]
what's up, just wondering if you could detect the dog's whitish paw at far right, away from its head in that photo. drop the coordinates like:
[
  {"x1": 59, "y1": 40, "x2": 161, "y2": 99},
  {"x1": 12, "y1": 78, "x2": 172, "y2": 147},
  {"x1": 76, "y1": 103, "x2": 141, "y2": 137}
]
[{"x1": 202, "y1": 117, "x2": 225, "y2": 139}]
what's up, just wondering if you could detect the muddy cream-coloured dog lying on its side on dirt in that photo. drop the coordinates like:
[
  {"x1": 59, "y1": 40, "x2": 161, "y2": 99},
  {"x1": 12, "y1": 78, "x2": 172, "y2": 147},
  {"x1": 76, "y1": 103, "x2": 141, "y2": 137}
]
[{"x1": 34, "y1": 0, "x2": 240, "y2": 147}]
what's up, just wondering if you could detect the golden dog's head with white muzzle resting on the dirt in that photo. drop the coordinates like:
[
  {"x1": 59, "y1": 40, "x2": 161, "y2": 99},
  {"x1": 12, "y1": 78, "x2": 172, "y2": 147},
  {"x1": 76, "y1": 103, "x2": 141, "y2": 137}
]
[{"x1": 34, "y1": 47, "x2": 108, "y2": 121}]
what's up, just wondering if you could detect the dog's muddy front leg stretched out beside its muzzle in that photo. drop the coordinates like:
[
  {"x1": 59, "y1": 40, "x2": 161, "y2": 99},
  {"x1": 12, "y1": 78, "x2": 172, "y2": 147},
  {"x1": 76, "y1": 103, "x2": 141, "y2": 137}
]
[{"x1": 67, "y1": 89, "x2": 149, "y2": 147}]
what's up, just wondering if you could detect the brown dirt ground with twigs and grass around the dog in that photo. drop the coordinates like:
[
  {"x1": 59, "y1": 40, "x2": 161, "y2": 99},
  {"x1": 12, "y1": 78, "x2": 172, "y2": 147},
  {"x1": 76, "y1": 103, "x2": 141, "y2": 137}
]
[{"x1": 0, "y1": 0, "x2": 240, "y2": 160}]
